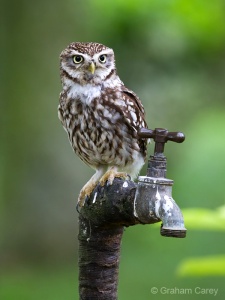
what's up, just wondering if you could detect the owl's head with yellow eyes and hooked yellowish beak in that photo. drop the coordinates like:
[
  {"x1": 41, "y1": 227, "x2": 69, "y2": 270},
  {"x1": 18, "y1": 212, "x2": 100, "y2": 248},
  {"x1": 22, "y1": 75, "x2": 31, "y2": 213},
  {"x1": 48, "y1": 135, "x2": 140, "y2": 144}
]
[{"x1": 60, "y1": 42, "x2": 116, "y2": 84}]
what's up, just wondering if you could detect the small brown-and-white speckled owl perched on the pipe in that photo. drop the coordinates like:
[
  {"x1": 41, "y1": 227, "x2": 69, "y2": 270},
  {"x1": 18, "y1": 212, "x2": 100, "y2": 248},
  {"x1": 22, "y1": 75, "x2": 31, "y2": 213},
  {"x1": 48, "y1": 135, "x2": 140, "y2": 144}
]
[{"x1": 58, "y1": 42, "x2": 147, "y2": 207}]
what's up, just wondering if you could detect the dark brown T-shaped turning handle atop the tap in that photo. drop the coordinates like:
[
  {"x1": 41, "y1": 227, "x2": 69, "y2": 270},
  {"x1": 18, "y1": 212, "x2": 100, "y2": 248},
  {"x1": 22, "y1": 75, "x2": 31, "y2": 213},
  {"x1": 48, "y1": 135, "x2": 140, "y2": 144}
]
[{"x1": 138, "y1": 128, "x2": 185, "y2": 155}]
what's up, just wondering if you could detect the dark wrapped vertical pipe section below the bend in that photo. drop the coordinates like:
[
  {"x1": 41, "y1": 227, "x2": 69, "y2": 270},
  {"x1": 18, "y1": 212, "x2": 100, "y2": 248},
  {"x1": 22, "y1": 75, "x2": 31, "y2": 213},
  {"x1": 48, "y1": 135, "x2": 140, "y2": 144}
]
[{"x1": 78, "y1": 214, "x2": 123, "y2": 300}]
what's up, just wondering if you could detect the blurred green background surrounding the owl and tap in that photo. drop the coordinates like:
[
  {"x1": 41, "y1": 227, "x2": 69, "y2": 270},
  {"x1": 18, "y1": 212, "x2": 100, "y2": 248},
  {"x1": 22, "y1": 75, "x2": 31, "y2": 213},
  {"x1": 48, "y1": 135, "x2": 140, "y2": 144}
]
[{"x1": 0, "y1": 0, "x2": 225, "y2": 300}]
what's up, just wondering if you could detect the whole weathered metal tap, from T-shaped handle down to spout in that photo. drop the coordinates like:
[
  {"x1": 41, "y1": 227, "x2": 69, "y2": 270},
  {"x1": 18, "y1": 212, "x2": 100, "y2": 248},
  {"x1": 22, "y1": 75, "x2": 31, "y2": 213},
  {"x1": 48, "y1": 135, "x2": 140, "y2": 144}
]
[{"x1": 134, "y1": 128, "x2": 186, "y2": 238}]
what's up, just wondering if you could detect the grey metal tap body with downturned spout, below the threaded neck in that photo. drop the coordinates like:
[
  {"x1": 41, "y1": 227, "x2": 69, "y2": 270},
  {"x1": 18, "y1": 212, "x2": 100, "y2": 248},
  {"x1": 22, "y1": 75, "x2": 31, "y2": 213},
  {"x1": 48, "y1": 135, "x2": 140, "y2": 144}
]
[{"x1": 134, "y1": 176, "x2": 186, "y2": 238}]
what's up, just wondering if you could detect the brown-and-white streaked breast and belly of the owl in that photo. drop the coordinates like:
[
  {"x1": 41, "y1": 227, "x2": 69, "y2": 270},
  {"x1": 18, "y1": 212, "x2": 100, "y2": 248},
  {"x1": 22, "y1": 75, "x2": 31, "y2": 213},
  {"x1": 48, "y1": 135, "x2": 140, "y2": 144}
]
[{"x1": 61, "y1": 89, "x2": 144, "y2": 169}]
